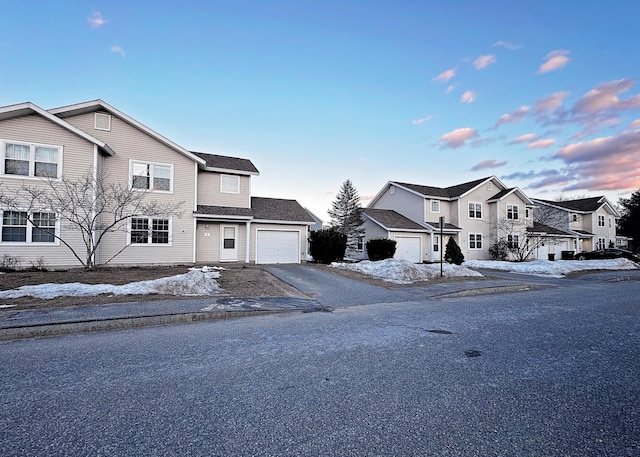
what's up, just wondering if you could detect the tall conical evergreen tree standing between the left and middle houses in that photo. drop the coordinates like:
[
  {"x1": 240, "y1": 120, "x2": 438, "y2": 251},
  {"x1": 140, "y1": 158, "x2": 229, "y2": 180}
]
[{"x1": 328, "y1": 179, "x2": 364, "y2": 251}]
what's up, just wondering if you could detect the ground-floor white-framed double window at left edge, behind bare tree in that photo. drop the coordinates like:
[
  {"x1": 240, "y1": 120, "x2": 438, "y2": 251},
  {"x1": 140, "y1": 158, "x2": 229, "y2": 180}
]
[{"x1": 2, "y1": 211, "x2": 56, "y2": 243}]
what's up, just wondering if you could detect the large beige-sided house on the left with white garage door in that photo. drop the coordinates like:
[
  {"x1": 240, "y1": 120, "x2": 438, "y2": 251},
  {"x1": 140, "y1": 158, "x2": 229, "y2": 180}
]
[{"x1": 0, "y1": 100, "x2": 314, "y2": 266}]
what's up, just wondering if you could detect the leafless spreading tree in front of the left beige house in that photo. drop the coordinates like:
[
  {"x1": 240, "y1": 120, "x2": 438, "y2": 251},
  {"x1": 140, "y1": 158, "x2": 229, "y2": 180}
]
[{"x1": 0, "y1": 173, "x2": 184, "y2": 269}]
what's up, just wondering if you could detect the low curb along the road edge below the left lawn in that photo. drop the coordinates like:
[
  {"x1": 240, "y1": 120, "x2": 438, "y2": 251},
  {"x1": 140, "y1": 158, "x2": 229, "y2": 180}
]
[{"x1": 0, "y1": 309, "x2": 301, "y2": 341}]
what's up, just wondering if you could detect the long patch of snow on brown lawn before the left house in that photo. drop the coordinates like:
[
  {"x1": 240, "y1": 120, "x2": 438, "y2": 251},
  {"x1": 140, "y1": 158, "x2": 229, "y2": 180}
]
[{"x1": 0, "y1": 267, "x2": 223, "y2": 300}]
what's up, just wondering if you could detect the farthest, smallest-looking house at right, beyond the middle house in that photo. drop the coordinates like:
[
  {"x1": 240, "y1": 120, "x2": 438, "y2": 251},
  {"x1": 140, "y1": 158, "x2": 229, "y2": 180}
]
[{"x1": 532, "y1": 196, "x2": 622, "y2": 252}]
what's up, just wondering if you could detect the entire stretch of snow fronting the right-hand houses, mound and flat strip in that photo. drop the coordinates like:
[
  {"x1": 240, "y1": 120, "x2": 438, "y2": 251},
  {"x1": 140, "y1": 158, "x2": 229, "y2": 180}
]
[{"x1": 332, "y1": 259, "x2": 639, "y2": 284}]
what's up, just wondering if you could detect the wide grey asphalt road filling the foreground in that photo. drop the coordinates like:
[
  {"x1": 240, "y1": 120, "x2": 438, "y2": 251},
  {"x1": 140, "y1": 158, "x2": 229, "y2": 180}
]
[{"x1": 0, "y1": 275, "x2": 640, "y2": 457}]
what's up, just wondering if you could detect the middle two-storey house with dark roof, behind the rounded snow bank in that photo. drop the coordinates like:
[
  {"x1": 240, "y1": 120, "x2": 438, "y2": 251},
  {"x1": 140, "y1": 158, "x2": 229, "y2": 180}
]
[{"x1": 362, "y1": 176, "x2": 534, "y2": 262}]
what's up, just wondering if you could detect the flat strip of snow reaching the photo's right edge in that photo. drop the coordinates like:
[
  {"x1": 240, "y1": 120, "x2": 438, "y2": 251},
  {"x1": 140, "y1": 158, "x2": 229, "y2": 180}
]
[{"x1": 464, "y1": 259, "x2": 640, "y2": 277}]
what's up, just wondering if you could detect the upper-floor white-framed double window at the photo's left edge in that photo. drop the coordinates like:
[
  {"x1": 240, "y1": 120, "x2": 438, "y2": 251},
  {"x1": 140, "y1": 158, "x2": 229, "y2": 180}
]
[{"x1": 0, "y1": 141, "x2": 62, "y2": 178}]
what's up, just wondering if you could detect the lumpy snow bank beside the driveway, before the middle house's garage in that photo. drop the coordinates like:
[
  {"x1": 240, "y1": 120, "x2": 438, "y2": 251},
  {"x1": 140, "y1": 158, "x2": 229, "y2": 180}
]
[{"x1": 331, "y1": 259, "x2": 482, "y2": 284}]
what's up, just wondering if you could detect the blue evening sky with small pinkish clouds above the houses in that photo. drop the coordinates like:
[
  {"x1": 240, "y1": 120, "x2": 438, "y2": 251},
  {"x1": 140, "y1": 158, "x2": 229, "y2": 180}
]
[{"x1": 0, "y1": 0, "x2": 640, "y2": 220}]
